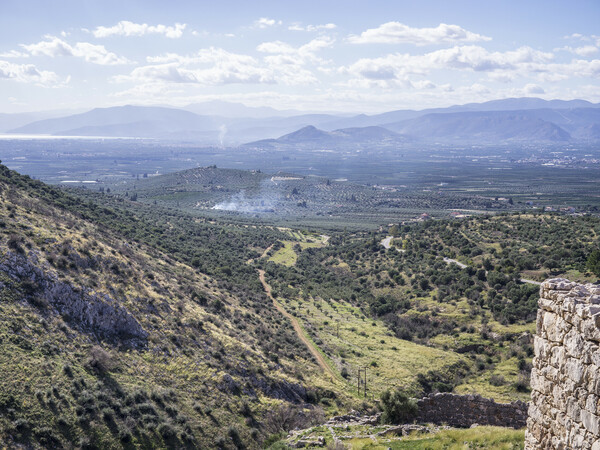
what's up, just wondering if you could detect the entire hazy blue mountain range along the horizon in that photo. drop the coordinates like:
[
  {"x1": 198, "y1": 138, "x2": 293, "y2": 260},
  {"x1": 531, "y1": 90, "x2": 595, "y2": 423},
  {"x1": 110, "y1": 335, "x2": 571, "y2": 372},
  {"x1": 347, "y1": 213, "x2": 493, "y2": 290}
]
[{"x1": 5, "y1": 98, "x2": 600, "y2": 146}]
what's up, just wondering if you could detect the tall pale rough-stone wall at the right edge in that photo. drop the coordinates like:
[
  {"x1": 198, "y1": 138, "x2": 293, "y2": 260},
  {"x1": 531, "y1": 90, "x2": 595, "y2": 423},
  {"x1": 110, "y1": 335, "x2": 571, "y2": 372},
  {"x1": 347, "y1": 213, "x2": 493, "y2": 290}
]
[{"x1": 525, "y1": 278, "x2": 600, "y2": 450}]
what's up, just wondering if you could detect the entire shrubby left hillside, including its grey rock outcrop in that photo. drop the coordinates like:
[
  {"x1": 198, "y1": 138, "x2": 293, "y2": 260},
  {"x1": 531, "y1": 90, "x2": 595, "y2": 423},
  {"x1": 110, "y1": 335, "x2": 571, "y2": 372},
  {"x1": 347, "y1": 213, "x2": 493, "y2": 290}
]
[{"x1": 0, "y1": 166, "x2": 338, "y2": 448}]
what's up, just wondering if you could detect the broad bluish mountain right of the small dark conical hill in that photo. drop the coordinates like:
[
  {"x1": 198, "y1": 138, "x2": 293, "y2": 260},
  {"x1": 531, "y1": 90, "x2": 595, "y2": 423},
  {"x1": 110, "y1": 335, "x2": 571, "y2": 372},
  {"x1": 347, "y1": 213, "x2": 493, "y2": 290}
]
[{"x1": 385, "y1": 111, "x2": 571, "y2": 143}]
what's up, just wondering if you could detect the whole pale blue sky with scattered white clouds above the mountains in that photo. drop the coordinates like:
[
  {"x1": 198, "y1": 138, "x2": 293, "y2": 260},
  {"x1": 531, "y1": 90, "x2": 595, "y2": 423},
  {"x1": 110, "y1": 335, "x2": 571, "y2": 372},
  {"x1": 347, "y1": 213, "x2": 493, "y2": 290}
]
[{"x1": 0, "y1": 0, "x2": 600, "y2": 113}]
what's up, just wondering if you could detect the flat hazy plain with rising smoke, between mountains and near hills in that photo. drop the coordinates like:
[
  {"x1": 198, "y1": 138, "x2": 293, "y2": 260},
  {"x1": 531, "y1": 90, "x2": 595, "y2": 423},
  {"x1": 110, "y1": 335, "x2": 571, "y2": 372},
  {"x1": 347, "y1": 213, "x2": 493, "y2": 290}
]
[{"x1": 0, "y1": 139, "x2": 600, "y2": 230}]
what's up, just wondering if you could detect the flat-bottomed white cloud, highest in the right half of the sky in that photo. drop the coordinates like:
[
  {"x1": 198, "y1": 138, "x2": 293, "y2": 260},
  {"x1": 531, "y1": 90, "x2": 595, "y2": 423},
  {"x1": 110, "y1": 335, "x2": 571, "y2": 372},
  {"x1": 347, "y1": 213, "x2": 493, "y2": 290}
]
[{"x1": 348, "y1": 22, "x2": 491, "y2": 45}]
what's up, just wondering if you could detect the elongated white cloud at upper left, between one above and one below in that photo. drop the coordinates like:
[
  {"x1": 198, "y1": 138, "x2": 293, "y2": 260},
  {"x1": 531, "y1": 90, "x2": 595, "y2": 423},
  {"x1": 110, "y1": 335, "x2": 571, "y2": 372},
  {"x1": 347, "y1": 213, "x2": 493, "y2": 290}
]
[{"x1": 21, "y1": 36, "x2": 130, "y2": 66}]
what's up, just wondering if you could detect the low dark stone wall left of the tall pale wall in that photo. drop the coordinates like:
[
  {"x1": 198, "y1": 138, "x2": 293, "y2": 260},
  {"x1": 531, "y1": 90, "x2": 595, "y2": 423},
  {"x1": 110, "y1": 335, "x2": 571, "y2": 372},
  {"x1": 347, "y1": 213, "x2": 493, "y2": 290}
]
[{"x1": 417, "y1": 393, "x2": 527, "y2": 428}]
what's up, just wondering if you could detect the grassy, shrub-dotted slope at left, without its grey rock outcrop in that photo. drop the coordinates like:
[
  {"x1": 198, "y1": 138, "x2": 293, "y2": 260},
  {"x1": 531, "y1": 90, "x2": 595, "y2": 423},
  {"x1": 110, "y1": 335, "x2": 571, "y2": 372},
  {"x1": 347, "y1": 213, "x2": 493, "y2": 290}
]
[{"x1": 0, "y1": 166, "x2": 332, "y2": 448}]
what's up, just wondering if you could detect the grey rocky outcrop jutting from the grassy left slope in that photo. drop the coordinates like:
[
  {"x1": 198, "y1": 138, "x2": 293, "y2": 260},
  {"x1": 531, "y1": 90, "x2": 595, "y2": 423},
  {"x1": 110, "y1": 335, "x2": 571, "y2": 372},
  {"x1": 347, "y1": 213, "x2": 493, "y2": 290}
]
[{"x1": 0, "y1": 252, "x2": 148, "y2": 347}]
